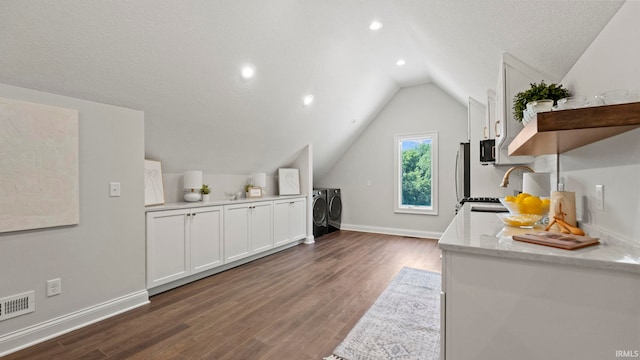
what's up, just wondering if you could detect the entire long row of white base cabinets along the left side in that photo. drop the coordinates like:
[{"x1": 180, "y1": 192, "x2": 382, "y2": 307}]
[{"x1": 146, "y1": 196, "x2": 307, "y2": 292}]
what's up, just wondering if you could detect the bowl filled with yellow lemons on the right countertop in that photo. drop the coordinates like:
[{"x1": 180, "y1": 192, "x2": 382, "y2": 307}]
[{"x1": 499, "y1": 193, "x2": 551, "y2": 227}]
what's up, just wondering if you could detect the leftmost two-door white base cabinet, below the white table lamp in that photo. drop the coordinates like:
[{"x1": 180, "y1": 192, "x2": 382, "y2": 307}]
[{"x1": 147, "y1": 206, "x2": 223, "y2": 288}]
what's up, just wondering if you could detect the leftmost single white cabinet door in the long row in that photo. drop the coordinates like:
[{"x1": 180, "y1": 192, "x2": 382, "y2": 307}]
[{"x1": 147, "y1": 210, "x2": 190, "y2": 288}]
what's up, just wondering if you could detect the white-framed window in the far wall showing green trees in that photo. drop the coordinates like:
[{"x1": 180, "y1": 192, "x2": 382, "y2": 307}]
[{"x1": 394, "y1": 132, "x2": 438, "y2": 215}]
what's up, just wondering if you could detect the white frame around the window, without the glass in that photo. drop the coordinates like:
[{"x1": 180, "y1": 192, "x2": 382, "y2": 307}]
[{"x1": 393, "y1": 131, "x2": 439, "y2": 215}]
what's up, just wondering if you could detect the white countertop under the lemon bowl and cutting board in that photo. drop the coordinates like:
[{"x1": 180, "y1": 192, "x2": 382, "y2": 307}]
[{"x1": 438, "y1": 203, "x2": 640, "y2": 273}]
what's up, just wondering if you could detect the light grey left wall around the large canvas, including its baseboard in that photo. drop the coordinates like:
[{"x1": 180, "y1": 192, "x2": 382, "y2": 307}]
[{"x1": 0, "y1": 84, "x2": 148, "y2": 356}]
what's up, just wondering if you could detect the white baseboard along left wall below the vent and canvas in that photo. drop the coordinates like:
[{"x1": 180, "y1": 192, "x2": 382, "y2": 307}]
[{"x1": 0, "y1": 290, "x2": 149, "y2": 357}]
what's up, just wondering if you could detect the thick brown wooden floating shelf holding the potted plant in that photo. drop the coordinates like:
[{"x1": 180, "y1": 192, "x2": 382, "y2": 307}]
[{"x1": 509, "y1": 102, "x2": 640, "y2": 156}]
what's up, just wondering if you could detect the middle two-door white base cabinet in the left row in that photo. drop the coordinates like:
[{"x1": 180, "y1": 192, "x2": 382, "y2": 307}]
[{"x1": 224, "y1": 201, "x2": 273, "y2": 263}]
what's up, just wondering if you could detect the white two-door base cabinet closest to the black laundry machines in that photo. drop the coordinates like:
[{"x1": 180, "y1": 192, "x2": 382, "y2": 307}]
[{"x1": 273, "y1": 198, "x2": 307, "y2": 246}]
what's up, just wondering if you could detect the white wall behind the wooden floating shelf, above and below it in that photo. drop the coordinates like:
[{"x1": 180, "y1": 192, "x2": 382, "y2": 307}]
[{"x1": 536, "y1": 1, "x2": 640, "y2": 244}]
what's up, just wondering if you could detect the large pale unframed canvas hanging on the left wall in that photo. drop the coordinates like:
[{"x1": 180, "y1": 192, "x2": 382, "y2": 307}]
[{"x1": 0, "y1": 98, "x2": 80, "y2": 232}]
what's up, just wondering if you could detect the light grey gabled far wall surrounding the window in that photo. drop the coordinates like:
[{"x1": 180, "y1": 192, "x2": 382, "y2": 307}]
[{"x1": 314, "y1": 84, "x2": 467, "y2": 237}]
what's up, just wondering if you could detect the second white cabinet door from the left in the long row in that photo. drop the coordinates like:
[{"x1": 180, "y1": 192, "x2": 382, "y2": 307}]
[{"x1": 188, "y1": 206, "x2": 223, "y2": 273}]
